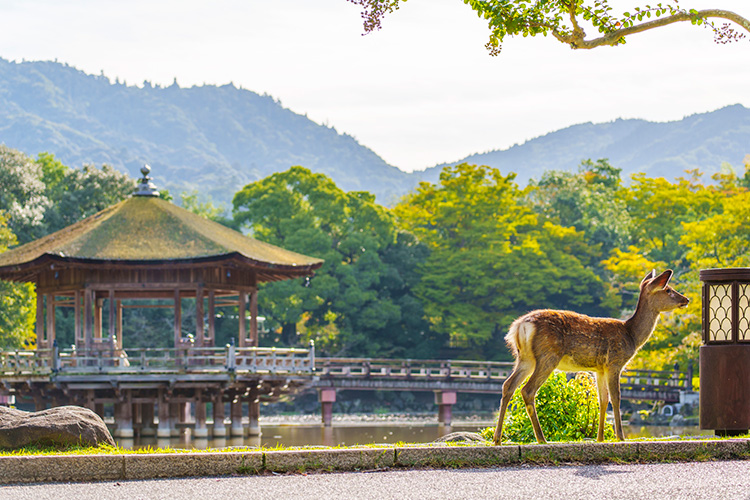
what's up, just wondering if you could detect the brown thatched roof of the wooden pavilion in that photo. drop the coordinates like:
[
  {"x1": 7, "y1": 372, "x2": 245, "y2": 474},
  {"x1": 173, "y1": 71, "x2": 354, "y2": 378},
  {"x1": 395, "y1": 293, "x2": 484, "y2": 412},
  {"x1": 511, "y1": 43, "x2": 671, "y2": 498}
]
[{"x1": 0, "y1": 196, "x2": 323, "y2": 279}]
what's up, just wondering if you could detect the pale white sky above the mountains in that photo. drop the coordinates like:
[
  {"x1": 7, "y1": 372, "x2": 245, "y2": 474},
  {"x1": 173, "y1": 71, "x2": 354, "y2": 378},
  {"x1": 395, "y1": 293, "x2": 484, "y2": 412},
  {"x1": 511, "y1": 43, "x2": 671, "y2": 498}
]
[{"x1": 0, "y1": 0, "x2": 750, "y2": 171}]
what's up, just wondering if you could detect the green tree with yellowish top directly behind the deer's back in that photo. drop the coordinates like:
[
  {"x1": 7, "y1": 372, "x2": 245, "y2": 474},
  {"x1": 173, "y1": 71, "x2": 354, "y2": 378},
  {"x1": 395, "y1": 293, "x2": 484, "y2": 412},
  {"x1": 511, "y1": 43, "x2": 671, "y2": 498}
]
[{"x1": 394, "y1": 164, "x2": 616, "y2": 358}]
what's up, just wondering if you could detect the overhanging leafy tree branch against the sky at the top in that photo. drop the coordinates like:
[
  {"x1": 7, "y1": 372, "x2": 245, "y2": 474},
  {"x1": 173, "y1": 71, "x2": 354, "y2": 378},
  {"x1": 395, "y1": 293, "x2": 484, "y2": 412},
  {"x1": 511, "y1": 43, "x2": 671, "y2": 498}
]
[{"x1": 348, "y1": 0, "x2": 750, "y2": 55}]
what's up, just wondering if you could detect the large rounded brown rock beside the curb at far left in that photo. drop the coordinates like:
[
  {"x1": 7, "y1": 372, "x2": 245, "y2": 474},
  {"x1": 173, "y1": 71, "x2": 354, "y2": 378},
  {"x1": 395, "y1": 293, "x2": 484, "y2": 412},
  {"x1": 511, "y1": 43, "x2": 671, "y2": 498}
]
[{"x1": 0, "y1": 406, "x2": 115, "y2": 449}]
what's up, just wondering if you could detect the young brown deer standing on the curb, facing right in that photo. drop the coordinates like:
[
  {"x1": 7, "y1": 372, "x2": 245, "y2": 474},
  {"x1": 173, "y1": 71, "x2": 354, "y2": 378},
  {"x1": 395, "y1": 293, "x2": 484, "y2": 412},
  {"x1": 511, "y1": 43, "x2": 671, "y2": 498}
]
[{"x1": 495, "y1": 270, "x2": 688, "y2": 445}]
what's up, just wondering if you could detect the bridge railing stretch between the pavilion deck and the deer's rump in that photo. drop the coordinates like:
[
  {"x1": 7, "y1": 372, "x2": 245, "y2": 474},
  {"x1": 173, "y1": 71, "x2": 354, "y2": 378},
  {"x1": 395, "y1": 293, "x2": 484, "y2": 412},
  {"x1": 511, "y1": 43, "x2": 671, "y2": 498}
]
[{"x1": 315, "y1": 358, "x2": 513, "y2": 381}]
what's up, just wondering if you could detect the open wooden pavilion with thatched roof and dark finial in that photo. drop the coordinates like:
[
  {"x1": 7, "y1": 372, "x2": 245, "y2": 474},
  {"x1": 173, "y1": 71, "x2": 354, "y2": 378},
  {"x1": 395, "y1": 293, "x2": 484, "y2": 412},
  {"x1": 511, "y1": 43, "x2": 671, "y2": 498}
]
[{"x1": 0, "y1": 166, "x2": 323, "y2": 434}]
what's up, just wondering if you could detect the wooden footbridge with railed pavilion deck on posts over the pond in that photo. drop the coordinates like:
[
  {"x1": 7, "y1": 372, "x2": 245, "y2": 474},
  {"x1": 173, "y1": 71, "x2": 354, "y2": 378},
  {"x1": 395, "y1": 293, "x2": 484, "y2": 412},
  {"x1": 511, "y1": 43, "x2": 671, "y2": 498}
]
[{"x1": 0, "y1": 345, "x2": 692, "y2": 437}]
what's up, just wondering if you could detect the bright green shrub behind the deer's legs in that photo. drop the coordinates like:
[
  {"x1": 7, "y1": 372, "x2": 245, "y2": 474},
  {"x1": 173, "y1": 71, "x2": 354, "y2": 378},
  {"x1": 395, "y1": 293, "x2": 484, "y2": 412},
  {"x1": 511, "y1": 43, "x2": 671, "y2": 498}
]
[{"x1": 482, "y1": 371, "x2": 615, "y2": 443}]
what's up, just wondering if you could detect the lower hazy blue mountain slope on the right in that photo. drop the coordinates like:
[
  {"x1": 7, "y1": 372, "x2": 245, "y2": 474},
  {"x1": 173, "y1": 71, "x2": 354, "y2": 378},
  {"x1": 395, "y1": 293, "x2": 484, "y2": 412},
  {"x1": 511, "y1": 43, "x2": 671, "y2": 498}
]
[{"x1": 420, "y1": 104, "x2": 750, "y2": 185}]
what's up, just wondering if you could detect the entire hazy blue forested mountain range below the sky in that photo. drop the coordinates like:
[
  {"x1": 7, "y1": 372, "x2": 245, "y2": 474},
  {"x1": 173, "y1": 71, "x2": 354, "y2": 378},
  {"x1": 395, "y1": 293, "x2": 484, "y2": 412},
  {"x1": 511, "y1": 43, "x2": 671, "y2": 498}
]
[{"x1": 0, "y1": 58, "x2": 750, "y2": 204}]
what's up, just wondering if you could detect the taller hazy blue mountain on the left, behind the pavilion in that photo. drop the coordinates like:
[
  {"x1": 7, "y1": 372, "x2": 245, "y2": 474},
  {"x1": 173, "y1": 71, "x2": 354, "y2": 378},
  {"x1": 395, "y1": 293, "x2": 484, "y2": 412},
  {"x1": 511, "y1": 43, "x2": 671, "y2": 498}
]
[{"x1": 0, "y1": 59, "x2": 411, "y2": 203}]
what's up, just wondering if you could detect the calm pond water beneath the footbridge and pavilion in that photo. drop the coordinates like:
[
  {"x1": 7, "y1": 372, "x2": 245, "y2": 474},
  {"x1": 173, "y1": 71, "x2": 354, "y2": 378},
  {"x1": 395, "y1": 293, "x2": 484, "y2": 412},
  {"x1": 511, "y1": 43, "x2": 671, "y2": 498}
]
[{"x1": 117, "y1": 419, "x2": 713, "y2": 449}]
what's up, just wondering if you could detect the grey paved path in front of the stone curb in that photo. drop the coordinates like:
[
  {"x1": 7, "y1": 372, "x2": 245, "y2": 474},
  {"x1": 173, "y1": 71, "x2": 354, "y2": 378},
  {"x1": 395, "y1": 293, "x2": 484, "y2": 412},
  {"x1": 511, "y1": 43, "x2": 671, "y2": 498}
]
[{"x1": 0, "y1": 461, "x2": 750, "y2": 500}]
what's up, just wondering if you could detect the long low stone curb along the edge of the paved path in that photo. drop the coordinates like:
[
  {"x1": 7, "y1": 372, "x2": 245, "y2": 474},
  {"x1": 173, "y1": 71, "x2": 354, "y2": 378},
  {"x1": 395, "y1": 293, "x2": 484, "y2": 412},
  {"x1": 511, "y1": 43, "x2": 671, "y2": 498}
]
[{"x1": 0, "y1": 439, "x2": 750, "y2": 484}]
